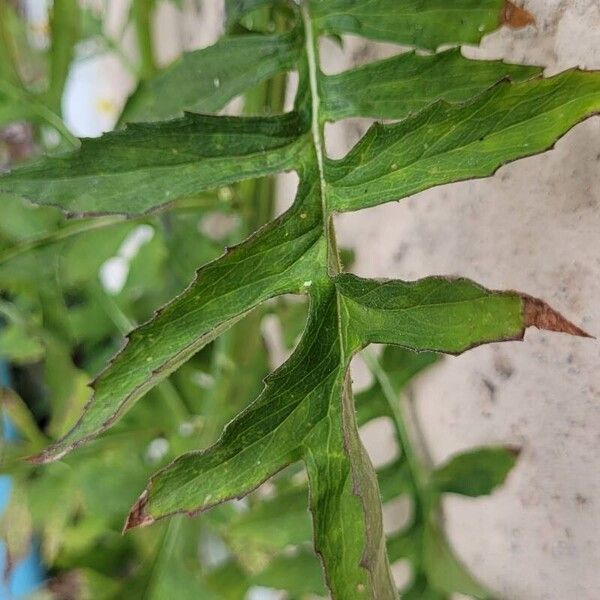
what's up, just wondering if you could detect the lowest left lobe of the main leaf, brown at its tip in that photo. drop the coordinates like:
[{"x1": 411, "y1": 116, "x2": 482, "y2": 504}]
[{"x1": 126, "y1": 286, "x2": 341, "y2": 528}]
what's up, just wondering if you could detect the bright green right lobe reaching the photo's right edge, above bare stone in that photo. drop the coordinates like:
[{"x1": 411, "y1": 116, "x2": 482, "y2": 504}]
[{"x1": 327, "y1": 71, "x2": 600, "y2": 211}]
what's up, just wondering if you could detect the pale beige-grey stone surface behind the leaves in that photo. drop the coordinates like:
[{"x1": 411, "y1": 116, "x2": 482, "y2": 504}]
[{"x1": 65, "y1": 0, "x2": 600, "y2": 600}]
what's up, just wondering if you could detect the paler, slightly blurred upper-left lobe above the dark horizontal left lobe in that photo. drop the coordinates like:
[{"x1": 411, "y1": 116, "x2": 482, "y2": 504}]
[{"x1": 120, "y1": 32, "x2": 301, "y2": 123}]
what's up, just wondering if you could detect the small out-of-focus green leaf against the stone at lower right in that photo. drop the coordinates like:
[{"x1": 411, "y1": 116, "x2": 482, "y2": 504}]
[{"x1": 432, "y1": 446, "x2": 518, "y2": 496}]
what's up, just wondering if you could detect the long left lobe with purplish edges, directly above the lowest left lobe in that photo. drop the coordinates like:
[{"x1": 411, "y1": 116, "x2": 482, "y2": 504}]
[{"x1": 31, "y1": 197, "x2": 323, "y2": 462}]
